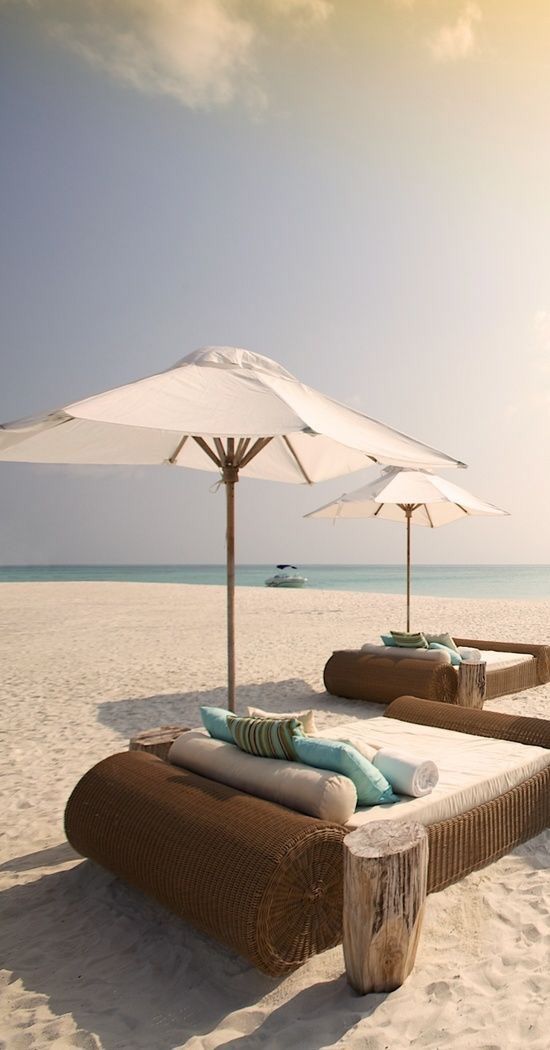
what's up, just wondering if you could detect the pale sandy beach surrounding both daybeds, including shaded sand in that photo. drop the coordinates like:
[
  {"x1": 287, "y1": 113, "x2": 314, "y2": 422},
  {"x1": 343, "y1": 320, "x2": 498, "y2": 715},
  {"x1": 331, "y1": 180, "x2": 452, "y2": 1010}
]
[{"x1": 0, "y1": 583, "x2": 550, "y2": 1050}]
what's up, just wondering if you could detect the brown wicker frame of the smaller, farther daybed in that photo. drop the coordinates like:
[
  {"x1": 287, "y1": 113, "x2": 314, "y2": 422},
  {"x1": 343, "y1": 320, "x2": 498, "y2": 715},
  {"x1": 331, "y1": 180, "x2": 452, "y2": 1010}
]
[{"x1": 323, "y1": 638, "x2": 550, "y2": 704}]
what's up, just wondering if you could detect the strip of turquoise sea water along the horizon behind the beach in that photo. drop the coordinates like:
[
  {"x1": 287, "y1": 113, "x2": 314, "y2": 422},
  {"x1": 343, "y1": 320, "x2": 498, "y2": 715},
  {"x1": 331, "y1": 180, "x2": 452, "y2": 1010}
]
[{"x1": 0, "y1": 565, "x2": 550, "y2": 599}]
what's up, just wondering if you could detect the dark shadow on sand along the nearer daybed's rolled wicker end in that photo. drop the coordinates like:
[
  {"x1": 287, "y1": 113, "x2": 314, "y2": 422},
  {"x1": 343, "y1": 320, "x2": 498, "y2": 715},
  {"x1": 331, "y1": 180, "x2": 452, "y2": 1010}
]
[{"x1": 1, "y1": 844, "x2": 381, "y2": 1050}]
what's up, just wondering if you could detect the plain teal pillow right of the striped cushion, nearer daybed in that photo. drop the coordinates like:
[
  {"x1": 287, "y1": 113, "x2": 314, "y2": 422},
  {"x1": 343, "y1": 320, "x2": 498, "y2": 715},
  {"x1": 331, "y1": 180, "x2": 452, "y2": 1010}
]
[{"x1": 293, "y1": 736, "x2": 398, "y2": 805}]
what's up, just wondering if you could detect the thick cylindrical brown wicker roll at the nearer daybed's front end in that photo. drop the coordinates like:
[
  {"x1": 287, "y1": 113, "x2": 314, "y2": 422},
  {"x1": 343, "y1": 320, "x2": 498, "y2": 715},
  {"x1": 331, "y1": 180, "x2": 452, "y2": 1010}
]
[{"x1": 65, "y1": 752, "x2": 344, "y2": 975}]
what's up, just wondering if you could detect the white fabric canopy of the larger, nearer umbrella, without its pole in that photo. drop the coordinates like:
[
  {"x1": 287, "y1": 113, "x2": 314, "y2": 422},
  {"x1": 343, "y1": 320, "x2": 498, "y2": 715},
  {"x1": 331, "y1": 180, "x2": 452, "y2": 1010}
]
[{"x1": 0, "y1": 347, "x2": 464, "y2": 472}]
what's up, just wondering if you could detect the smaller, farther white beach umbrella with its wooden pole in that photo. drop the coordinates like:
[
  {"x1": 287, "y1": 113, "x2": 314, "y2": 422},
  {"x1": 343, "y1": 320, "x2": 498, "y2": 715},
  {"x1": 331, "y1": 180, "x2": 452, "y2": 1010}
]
[{"x1": 304, "y1": 466, "x2": 508, "y2": 631}]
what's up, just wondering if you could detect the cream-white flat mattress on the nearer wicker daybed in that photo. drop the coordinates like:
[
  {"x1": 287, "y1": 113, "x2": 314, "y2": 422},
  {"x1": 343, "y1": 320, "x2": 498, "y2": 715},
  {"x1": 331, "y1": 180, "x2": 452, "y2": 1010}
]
[{"x1": 312, "y1": 716, "x2": 550, "y2": 827}]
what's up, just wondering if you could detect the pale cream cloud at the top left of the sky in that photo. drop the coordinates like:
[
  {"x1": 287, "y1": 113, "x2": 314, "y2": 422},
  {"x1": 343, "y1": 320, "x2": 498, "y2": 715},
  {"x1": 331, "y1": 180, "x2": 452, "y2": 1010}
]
[{"x1": 8, "y1": 0, "x2": 333, "y2": 110}]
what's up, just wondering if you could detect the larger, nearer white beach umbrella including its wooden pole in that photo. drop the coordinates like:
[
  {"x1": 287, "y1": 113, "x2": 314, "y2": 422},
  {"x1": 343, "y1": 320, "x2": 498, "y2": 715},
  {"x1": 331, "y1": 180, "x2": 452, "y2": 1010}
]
[{"x1": 0, "y1": 347, "x2": 464, "y2": 710}]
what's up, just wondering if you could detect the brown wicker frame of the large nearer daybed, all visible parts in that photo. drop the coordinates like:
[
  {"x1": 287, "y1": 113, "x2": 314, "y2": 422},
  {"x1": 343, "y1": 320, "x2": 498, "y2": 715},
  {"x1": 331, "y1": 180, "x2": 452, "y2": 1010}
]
[{"x1": 65, "y1": 697, "x2": 550, "y2": 975}]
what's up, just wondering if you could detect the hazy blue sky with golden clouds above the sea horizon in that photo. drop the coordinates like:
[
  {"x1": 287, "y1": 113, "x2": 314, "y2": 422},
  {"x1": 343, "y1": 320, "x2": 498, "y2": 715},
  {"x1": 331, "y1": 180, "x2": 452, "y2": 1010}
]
[{"x1": 0, "y1": 0, "x2": 550, "y2": 564}]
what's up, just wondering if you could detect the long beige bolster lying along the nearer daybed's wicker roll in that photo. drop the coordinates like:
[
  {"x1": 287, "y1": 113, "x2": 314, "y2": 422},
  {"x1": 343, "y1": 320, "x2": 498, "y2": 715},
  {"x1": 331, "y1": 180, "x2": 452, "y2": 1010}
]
[{"x1": 168, "y1": 730, "x2": 358, "y2": 824}]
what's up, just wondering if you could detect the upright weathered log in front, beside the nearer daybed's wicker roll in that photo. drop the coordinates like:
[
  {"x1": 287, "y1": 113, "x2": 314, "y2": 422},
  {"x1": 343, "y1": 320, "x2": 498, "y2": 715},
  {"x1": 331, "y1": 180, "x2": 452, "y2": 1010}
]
[{"x1": 343, "y1": 820, "x2": 428, "y2": 995}]
